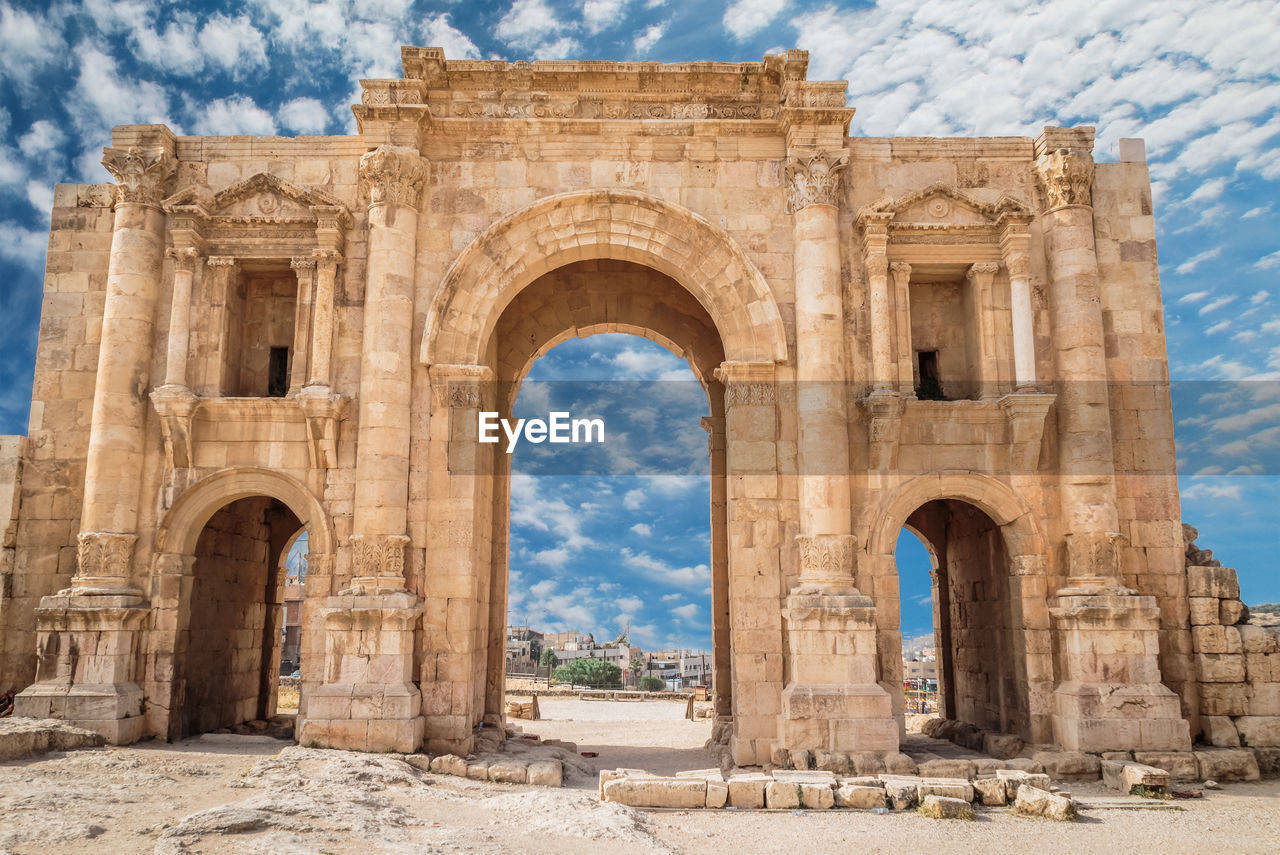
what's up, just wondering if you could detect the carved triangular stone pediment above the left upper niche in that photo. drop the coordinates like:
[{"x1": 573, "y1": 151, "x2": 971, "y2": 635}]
[{"x1": 164, "y1": 173, "x2": 352, "y2": 260}]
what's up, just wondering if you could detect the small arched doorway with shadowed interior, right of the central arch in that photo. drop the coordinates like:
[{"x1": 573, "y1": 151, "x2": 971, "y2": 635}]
[{"x1": 868, "y1": 472, "x2": 1055, "y2": 742}]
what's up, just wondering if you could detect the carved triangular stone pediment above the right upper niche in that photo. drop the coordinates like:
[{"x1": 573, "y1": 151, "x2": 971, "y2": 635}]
[{"x1": 858, "y1": 182, "x2": 1034, "y2": 262}]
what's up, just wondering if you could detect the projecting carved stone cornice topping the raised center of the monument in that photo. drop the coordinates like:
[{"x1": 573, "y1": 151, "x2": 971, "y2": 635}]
[{"x1": 353, "y1": 47, "x2": 852, "y2": 127}]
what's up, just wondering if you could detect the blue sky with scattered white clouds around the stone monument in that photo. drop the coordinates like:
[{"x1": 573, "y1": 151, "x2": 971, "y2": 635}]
[{"x1": 0, "y1": 0, "x2": 1280, "y2": 646}]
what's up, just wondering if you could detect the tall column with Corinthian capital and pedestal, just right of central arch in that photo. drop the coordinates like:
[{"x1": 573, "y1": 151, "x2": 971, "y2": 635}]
[{"x1": 777, "y1": 151, "x2": 899, "y2": 751}]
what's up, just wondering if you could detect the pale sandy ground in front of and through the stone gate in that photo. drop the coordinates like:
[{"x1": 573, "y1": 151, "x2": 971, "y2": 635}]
[{"x1": 0, "y1": 699, "x2": 1280, "y2": 855}]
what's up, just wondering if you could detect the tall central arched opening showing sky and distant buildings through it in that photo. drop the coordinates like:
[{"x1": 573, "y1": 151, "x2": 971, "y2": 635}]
[{"x1": 486, "y1": 259, "x2": 731, "y2": 771}]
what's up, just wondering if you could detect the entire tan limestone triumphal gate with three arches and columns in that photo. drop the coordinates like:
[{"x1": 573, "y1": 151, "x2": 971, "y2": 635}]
[{"x1": 0, "y1": 47, "x2": 1249, "y2": 762}]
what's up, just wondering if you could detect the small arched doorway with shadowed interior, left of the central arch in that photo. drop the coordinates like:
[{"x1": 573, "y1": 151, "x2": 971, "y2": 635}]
[{"x1": 151, "y1": 470, "x2": 333, "y2": 740}]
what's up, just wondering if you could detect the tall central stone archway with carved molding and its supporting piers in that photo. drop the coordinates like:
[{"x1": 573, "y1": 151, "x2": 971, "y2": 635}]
[{"x1": 422, "y1": 191, "x2": 787, "y2": 764}]
